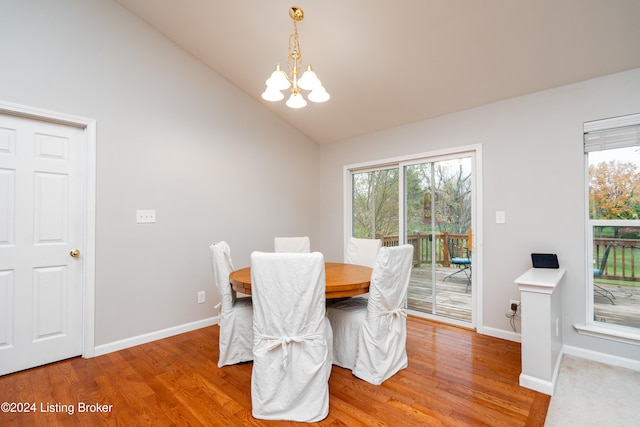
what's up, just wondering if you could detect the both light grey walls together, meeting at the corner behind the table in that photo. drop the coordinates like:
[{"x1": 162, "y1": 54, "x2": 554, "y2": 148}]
[{"x1": 0, "y1": 0, "x2": 640, "y2": 359}]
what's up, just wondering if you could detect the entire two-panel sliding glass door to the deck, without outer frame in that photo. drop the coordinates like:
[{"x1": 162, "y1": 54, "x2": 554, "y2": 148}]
[{"x1": 349, "y1": 151, "x2": 475, "y2": 327}]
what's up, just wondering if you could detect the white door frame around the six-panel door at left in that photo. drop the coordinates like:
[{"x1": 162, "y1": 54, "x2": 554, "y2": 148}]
[{"x1": 0, "y1": 101, "x2": 96, "y2": 358}]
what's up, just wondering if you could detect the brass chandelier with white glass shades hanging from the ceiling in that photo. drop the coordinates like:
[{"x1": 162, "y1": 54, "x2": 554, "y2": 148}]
[{"x1": 262, "y1": 7, "x2": 330, "y2": 108}]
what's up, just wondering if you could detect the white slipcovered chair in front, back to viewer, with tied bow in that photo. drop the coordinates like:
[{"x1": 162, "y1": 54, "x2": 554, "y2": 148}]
[{"x1": 251, "y1": 252, "x2": 332, "y2": 422}]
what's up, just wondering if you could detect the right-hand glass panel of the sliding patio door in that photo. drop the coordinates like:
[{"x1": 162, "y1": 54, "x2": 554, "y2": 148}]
[{"x1": 404, "y1": 156, "x2": 473, "y2": 325}]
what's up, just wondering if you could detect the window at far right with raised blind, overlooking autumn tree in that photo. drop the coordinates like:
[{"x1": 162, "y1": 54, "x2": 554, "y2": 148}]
[{"x1": 584, "y1": 115, "x2": 640, "y2": 334}]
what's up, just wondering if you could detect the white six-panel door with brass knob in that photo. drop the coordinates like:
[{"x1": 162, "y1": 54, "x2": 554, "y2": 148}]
[{"x1": 0, "y1": 114, "x2": 84, "y2": 375}]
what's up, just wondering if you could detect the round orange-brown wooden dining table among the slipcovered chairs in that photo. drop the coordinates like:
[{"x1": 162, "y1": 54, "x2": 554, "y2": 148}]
[{"x1": 229, "y1": 262, "x2": 373, "y2": 299}]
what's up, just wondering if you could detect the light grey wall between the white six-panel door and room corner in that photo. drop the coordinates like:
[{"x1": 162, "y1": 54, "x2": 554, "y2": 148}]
[{"x1": 0, "y1": 0, "x2": 319, "y2": 345}]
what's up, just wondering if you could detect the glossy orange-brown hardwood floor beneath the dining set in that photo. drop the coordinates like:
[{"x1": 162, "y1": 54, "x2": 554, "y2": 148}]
[{"x1": 0, "y1": 316, "x2": 550, "y2": 427}]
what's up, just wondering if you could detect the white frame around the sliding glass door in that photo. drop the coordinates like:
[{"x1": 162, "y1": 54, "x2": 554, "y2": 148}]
[{"x1": 343, "y1": 144, "x2": 485, "y2": 334}]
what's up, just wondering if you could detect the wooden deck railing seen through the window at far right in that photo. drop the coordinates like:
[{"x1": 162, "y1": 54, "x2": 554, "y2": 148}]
[{"x1": 593, "y1": 239, "x2": 640, "y2": 282}]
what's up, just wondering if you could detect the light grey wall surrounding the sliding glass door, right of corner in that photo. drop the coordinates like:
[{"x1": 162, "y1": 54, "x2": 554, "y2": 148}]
[{"x1": 319, "y1": 69, "x2": 640, "y2": 360}]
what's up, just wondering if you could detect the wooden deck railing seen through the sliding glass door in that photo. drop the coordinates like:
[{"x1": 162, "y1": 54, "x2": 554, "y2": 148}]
[{"x1": 378, "y1": 232, "x2": 468, "y2": 267}]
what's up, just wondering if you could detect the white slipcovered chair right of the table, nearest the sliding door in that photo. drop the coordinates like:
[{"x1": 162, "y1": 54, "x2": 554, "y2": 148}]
[{"x1": 327, "y1": 245, "x2": 413, "y2": 385}]
